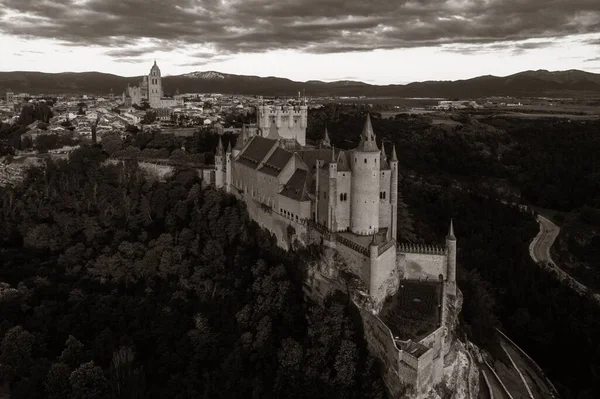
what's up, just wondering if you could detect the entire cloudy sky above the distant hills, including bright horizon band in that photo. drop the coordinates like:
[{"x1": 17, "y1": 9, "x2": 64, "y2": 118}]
[{"x1": 0, "y1": 0, "x2": 600, "y2": 84}]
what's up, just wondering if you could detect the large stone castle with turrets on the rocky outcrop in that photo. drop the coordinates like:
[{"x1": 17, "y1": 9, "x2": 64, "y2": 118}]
[{"x1": 211, "y1": 105, "x2": 460, "y2": 397}]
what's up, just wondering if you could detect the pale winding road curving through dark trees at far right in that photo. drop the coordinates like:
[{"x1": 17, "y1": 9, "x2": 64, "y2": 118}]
[{"x1": 529, "y1": 215, "x2": 600, "y2": 303}]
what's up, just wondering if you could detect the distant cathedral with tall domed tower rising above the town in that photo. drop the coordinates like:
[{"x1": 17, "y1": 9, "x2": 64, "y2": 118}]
[{"x1": 123, "y1": 60, "x2": 183, "y2": 108}]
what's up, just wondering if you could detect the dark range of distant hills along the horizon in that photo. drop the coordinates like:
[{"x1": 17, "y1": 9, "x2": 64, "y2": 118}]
[{"x1": 0, "y1": 70, "x2": 600, "y2": 99}]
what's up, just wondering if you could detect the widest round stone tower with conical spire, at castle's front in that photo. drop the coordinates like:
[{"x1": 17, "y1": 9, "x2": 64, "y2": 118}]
[{"x1": 350, "y1": 115, "x2": 380, "y2": 235}]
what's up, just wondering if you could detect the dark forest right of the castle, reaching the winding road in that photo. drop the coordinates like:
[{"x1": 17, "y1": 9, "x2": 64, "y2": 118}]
[{"x1": 307, "y1": 104, "x2": 600, "y2": 399}]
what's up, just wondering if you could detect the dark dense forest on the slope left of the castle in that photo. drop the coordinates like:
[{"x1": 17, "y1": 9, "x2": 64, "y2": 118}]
[{"x1": 0, "y1": 146, "x2": 386, "y2": 399}]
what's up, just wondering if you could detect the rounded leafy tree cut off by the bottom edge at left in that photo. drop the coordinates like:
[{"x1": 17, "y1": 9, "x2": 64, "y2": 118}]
[{"x1": 69, "y1": 361, "x2": 114, "y2": 399}]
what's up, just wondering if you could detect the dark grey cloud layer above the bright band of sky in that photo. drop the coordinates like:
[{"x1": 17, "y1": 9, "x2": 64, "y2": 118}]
[{"x1": 0, "y1": 0, "x2": 600, "y2": 57}]
